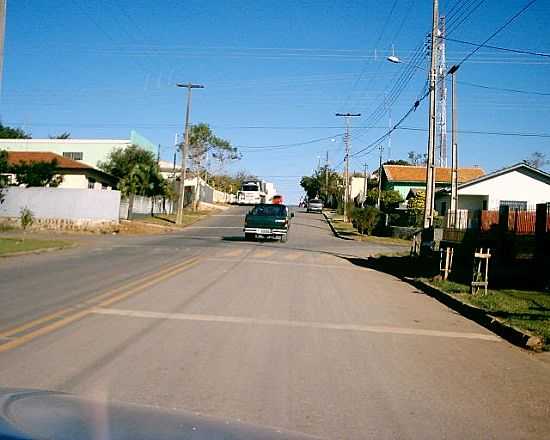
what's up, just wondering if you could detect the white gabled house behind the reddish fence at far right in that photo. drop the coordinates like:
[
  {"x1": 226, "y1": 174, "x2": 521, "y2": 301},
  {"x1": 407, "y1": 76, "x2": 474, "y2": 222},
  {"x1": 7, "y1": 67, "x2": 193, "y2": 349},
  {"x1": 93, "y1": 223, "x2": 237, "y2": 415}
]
[{"x1": 435, "y1": 163, "x2": 550, "y2": 214}]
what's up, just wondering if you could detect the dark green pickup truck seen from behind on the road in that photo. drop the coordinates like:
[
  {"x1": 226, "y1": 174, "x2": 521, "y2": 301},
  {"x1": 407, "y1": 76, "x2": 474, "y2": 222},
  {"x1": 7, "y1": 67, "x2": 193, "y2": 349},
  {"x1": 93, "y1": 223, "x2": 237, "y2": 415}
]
[{"x1": 244, "y1": 203, "x2": 294, "y2": 243}]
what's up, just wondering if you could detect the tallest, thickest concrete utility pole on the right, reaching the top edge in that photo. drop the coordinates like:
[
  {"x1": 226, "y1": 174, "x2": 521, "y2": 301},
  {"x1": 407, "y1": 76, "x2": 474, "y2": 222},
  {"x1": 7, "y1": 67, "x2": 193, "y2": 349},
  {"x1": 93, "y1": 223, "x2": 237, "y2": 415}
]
[{"x1": 424, "y1": 0, "x2": 439, "y2": 229}]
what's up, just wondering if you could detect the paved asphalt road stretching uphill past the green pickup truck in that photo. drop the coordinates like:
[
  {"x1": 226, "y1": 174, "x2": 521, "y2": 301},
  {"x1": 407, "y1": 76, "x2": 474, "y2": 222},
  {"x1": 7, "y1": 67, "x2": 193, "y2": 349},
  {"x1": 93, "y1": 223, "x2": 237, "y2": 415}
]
[{"x1": 0, "y1": 208, "x2": 550, "y2": 439}]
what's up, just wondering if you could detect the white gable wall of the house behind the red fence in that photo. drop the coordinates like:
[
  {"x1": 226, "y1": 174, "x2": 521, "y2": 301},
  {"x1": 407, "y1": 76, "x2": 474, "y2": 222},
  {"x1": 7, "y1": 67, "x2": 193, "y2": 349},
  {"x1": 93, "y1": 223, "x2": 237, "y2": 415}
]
[{"x1": 458, "y1": 171, "x2": 550, "y2": 209}]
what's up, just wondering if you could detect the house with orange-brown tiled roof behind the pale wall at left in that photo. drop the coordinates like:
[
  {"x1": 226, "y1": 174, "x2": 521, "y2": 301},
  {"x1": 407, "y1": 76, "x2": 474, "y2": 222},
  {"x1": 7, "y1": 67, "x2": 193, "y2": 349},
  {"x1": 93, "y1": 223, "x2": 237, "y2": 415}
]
[{"x1": 8, "y1": 151, "x2": 117, "y2": 190}]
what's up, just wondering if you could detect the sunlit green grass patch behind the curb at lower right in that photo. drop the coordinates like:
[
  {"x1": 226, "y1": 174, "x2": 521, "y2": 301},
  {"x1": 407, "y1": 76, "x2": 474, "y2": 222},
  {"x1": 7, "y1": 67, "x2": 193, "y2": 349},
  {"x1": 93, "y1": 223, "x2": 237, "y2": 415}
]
[{"x1": 430, "y1": 281, "x2": 550, "y2": 350}]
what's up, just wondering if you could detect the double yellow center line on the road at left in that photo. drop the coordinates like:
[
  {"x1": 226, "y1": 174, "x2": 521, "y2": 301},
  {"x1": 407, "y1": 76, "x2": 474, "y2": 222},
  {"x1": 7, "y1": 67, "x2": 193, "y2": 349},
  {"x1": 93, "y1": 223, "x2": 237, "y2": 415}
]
[{"x1": 0, "y1": 257, "x2": 200, "y2": 353}]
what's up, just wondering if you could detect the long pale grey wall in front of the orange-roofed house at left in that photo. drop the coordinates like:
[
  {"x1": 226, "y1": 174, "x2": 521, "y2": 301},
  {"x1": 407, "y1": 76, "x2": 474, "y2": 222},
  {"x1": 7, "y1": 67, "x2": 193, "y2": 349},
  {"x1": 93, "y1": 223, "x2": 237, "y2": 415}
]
[{"x1": 0, "y1": 187, "x2": 120, "y2": 223}]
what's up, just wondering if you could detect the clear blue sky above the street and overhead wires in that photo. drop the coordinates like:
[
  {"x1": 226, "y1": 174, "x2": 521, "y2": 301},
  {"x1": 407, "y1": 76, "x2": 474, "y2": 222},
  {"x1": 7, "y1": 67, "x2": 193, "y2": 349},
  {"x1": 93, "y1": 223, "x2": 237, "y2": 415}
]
[{"x1": 1, "y1": 0, "x2": 550, "y2": 201}]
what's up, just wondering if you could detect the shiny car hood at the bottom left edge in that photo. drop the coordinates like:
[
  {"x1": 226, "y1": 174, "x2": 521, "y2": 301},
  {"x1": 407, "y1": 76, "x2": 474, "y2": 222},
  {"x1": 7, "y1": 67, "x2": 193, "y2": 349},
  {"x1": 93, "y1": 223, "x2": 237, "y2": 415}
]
[{"x1": 0, "y1": 388, "x2": 322, "y2": 440}]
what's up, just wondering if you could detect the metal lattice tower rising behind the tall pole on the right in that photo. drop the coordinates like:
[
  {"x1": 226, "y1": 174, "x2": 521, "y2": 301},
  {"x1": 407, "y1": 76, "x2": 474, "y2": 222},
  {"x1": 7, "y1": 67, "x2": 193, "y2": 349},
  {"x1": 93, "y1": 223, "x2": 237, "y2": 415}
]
[{"x1": 435, "y1": 17, "x2": 447, "y2": 167}]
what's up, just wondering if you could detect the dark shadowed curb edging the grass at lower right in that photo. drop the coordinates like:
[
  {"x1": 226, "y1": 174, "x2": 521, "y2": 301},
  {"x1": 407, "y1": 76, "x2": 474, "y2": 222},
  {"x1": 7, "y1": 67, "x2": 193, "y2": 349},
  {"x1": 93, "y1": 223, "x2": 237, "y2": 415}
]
[{"x1": 403, "y1": 277, "x2": 544, "y2": 352}]
